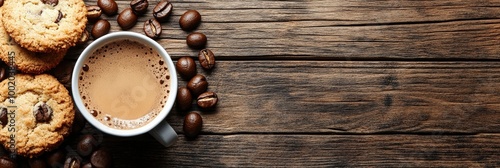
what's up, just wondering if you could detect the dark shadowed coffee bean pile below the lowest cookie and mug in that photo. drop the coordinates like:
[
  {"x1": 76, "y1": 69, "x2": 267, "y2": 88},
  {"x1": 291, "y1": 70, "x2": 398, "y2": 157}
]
[{"x1": 0, "y1": 111, "x2": 112, "y2": 168}]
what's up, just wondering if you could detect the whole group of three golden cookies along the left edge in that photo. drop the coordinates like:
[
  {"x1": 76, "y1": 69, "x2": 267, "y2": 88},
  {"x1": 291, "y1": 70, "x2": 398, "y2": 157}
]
[{"x1": 0, "y1": 0, "x2": 87, "y2": 157}]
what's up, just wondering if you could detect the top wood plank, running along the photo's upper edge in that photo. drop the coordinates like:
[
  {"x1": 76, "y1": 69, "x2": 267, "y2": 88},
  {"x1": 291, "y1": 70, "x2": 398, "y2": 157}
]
[{"x1": 68, "y1": 0, "x2": 500, "y2": 60}]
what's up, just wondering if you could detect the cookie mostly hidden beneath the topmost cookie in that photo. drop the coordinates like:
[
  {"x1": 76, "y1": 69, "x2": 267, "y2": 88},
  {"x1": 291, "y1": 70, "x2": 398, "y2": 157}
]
[{"x1": 0, "y1": 7, "x2": 66, "y2": 74}]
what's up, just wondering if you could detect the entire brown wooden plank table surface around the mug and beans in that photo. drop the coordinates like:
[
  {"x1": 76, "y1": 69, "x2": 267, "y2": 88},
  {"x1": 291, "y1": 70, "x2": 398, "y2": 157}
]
[{"x1": 67, "y1": 0, "x2": 500, "y2": 167}]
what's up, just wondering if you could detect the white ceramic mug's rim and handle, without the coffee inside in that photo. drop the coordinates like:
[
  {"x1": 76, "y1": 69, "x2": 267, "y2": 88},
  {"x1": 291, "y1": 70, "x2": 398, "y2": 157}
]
[{"x1": 71, "y1": 31, "x2": 177, "y2": 147}]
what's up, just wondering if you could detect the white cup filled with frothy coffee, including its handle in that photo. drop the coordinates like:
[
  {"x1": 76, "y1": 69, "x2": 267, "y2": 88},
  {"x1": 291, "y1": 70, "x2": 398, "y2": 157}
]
[{"x1": 71, "y1": 31, "x2": 178, "y2": 146}]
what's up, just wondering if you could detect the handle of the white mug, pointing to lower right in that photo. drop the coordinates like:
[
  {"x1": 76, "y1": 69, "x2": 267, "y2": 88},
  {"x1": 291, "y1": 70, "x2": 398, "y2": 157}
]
[{"x1": 149, "y1": 120, "x2": 177, "y2": 147}]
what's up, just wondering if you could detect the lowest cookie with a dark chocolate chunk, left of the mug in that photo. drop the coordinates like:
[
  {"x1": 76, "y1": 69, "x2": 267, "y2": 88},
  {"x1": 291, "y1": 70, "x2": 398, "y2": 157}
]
[{"x1": 0, "y1": 74, "x2": 75, "y2": 158}]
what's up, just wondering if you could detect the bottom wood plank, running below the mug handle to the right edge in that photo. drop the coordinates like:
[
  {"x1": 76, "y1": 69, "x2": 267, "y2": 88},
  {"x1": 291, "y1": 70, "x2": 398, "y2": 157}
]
[{"x1": 104, "y1": 134, "x2": 500, "y2": 167}]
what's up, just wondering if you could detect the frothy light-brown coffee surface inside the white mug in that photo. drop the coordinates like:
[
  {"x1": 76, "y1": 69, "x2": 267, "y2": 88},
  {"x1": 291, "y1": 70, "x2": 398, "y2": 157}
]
[{"x1": 78, "y1": 40, "x2": 170, "y2": 129}]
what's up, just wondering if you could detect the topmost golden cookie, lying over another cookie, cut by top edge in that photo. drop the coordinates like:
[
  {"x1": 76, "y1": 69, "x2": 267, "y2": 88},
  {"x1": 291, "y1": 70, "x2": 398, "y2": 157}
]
[{"x1": 2, "y1": 0, "x2": 87, "y2": 53}]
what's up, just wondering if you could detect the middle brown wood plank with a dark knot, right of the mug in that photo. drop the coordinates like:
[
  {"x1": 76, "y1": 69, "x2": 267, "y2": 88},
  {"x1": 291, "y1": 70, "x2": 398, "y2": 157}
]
[{"x1": 151, "y1": 61, "x2": 500, "y2": 134}]
